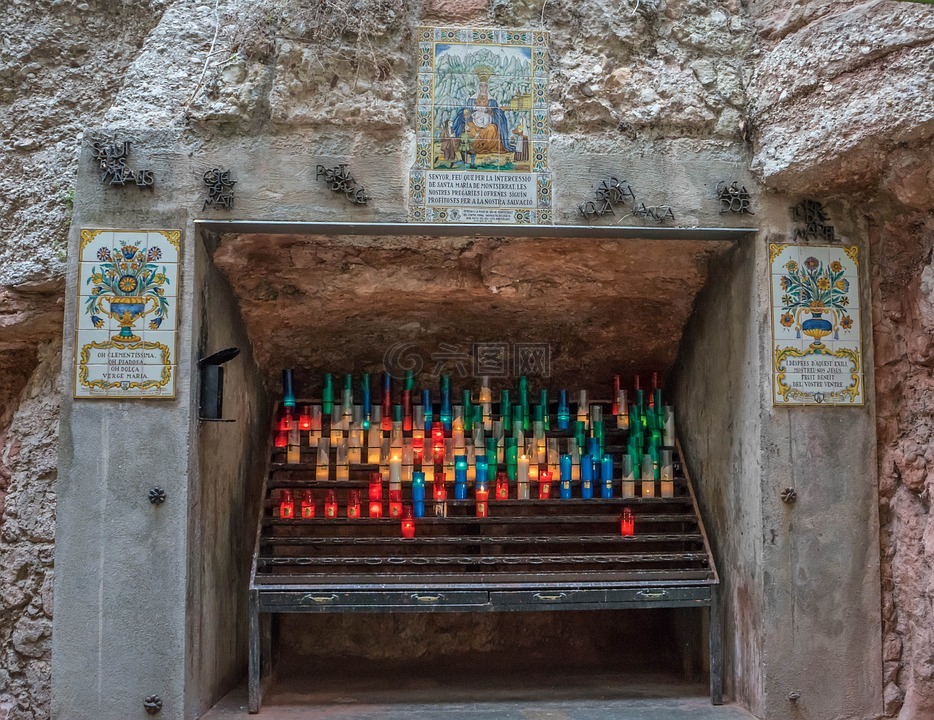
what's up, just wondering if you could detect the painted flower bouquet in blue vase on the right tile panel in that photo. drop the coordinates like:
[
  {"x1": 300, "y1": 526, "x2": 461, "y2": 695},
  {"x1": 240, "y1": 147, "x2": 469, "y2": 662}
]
[{"x1": 780, "y1": 256, "x2": 853, "y2": 345}]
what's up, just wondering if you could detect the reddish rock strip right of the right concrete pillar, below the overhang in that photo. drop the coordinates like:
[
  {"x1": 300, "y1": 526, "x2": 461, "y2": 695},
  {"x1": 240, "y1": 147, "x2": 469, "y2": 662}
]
[{"x1": 871, "y1": 205, "x2": 934, "y2": 720}]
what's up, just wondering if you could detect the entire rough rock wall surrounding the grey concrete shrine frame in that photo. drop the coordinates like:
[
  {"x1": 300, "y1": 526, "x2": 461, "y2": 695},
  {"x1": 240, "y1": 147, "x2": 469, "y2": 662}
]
[{"x1": 0, "y1": 0, "x2": 934, "y2": 720}]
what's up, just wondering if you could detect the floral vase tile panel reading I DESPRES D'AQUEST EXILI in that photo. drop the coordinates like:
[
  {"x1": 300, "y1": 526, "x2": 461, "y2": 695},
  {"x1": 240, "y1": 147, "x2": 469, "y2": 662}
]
[{"x1": 769, "y1": 245, "x2": 864, "y2": 405}]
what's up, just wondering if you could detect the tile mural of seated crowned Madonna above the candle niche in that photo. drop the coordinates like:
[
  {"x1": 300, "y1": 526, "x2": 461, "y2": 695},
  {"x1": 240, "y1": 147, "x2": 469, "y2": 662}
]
[{"x1": 408, "y1": 27, "x2": 553, "y2": 224}]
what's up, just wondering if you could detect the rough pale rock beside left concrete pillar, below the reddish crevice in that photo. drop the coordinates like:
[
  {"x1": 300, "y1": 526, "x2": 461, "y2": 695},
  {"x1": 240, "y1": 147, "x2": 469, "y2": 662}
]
[{"x1": 0, "y1": 345, "x2": 61, "y2": 720}]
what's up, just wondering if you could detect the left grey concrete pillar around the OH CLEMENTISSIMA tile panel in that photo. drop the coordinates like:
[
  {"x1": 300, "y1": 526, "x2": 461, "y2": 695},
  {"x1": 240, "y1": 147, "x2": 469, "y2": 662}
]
[{"x1": 52, "y1": 133, "x2": 197, "y2": 720}]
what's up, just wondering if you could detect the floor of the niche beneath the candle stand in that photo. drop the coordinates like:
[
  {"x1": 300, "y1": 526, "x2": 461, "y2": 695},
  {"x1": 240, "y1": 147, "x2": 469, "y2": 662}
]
[{"x1": 202, "y1": 665, "x2": 754, "y2": 720}]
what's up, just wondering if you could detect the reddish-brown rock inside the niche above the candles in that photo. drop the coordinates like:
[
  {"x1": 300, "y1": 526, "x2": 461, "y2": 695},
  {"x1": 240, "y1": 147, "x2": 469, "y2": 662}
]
[{"x1": 214, "y1": 235, "x2": 731, "y2": 392}]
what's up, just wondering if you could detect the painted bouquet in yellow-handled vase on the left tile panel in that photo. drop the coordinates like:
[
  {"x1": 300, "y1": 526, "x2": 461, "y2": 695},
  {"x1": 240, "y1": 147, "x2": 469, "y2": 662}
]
[{"x1": 86, "y1": 243, "x2": 169, "y2": 343}]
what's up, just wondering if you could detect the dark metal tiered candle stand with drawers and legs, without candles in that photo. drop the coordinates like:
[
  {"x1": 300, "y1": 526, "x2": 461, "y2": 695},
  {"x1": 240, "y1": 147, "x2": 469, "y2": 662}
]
[{"x1": 248, "y1": 401, "x2": 722, "y2": 713}]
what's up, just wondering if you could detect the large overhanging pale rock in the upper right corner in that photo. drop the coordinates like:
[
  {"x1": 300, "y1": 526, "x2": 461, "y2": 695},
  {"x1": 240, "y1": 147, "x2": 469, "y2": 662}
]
[{"x1": 749, "y1": 0, "x2": 934, "y2": 194}]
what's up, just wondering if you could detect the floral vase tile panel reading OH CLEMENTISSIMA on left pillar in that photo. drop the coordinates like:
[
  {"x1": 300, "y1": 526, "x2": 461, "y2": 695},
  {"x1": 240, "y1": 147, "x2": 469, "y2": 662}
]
[{"x1": 75, "y1": 229, "x2": 181, "y2": 399}]
